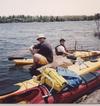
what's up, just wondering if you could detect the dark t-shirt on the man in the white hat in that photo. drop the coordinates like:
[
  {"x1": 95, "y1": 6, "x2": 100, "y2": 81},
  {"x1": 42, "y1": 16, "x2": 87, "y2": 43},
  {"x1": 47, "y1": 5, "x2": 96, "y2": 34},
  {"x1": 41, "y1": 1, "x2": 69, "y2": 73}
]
[{"x1": 34, "y1": 42, "x2": 53, "y2": 63}]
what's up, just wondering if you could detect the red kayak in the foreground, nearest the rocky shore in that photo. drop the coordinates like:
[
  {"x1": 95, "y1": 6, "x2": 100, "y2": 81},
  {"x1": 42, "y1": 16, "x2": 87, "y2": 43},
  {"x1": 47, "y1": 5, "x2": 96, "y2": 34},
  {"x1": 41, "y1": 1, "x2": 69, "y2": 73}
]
[{"x1": 0, "y1": 70, "x2": 100, "y2": 104}]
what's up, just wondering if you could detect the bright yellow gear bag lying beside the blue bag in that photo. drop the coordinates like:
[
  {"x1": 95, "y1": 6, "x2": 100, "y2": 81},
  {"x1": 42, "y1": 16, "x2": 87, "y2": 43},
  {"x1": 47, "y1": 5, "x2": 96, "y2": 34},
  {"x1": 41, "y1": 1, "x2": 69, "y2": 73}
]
[{"x1": 37, "y1": 68, "x2": 67, "y2": 91}]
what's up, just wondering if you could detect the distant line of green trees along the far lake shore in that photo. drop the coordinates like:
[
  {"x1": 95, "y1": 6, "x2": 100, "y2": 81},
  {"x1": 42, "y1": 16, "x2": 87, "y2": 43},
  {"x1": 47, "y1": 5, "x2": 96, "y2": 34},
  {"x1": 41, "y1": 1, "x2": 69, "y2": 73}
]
[{"x1": 0, "y1": 15, "x2": 95, "y2": 23}]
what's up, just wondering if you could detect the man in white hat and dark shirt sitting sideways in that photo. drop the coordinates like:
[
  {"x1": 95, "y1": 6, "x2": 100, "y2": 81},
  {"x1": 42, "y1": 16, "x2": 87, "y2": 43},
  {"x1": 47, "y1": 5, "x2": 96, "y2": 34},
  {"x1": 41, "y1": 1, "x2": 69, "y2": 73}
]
[{"x1": 30, "y1": 34, "x2": 53, "y2": 68}]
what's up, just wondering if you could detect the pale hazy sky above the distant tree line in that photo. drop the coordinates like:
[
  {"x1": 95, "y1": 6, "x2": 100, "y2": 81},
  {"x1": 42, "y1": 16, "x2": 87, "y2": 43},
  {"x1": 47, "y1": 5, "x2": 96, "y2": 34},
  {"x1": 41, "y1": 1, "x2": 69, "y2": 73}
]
[{"x1": 0, "y1": 0, "x2": 100, "y2": 16}]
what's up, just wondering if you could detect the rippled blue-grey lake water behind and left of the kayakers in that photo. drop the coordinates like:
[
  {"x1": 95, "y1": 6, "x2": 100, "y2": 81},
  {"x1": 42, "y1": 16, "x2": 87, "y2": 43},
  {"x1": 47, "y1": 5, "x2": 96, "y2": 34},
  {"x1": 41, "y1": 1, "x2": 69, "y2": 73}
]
[{"x1": 0, "y1": 21, "x2": 100, "y2": 87}]
